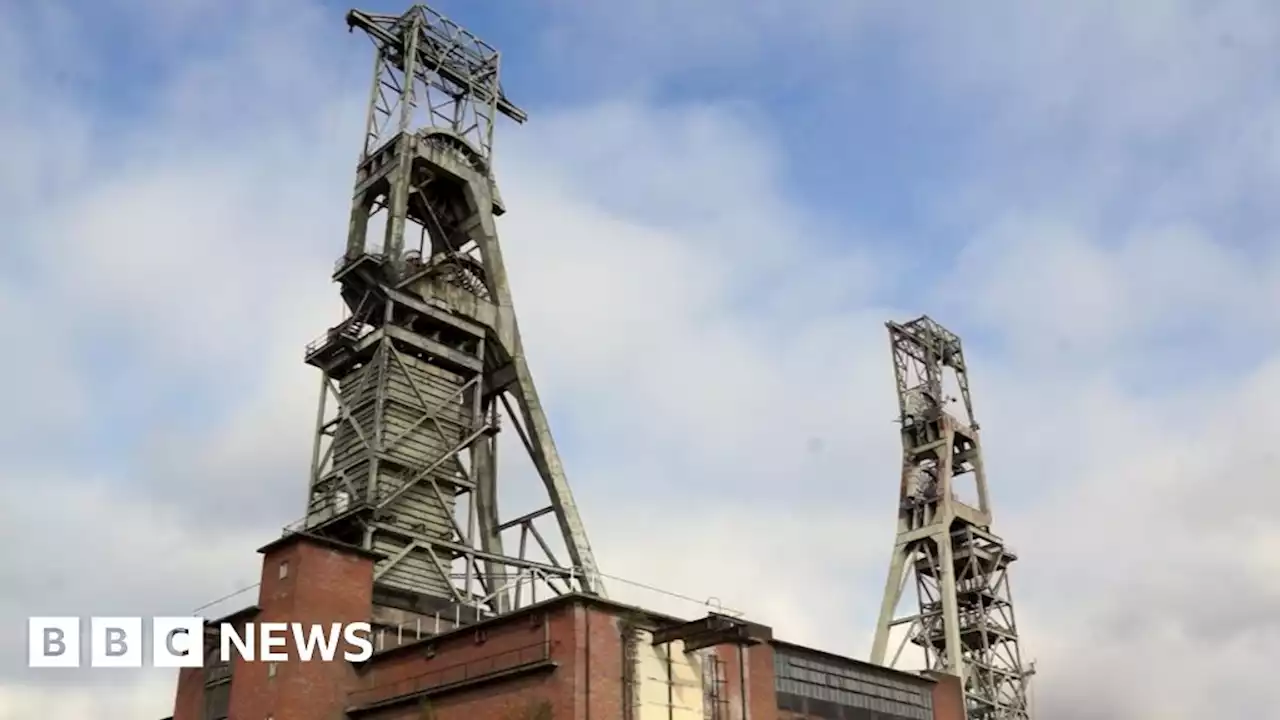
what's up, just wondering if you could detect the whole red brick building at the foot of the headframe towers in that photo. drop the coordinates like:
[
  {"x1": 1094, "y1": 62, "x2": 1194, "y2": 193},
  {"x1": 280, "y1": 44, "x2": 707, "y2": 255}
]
[{"x1": 162, "y1": 534, "x2": 964, "y2": 720}]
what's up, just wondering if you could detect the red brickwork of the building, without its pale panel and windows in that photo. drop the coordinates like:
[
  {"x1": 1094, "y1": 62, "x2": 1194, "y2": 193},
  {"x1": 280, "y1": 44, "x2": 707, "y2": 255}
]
[{"x1": 174, "y1": 536, "x2": 964, "y2": 720}]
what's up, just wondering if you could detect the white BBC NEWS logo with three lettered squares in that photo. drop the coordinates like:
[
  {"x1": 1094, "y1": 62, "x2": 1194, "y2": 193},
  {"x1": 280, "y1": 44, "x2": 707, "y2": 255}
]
[{"x1": 27, "y1": 618, "x2": 374, "y2": 667}]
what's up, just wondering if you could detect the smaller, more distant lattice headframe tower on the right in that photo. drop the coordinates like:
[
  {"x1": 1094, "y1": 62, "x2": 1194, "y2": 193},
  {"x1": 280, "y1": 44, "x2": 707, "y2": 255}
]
[{"x1": 872, "y1": 316, "x2": 1030, "y2": 720}]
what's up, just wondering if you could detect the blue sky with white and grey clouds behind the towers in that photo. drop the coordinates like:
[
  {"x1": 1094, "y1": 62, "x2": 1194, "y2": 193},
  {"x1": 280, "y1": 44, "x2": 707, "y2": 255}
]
[{"x1": 0, "y1": 0, "x2": 1280, "y2": 720}]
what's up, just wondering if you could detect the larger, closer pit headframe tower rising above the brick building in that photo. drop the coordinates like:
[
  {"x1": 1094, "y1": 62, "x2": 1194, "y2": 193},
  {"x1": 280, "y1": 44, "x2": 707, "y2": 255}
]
[{"x1": 302, "y1": 5, "x2": 603, "y2": 616}]
